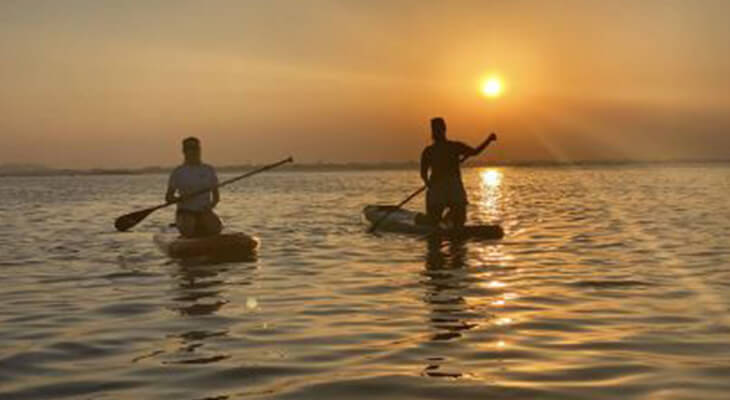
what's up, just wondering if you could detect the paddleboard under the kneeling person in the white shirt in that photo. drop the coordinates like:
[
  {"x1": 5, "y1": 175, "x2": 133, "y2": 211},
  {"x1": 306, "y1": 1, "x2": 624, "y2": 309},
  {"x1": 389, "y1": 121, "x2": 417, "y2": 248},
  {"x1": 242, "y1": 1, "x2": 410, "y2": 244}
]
[{"x1": 154, "y1": 232, "x2": 259, "y2": 259}]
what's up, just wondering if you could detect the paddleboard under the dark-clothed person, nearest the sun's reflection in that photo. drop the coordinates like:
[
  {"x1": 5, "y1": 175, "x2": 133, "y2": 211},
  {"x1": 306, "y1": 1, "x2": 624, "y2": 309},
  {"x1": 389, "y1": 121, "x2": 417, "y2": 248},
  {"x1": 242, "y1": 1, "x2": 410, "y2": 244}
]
[{"x1": 362, "y1": 205, "x2": 504, "y2": 239}]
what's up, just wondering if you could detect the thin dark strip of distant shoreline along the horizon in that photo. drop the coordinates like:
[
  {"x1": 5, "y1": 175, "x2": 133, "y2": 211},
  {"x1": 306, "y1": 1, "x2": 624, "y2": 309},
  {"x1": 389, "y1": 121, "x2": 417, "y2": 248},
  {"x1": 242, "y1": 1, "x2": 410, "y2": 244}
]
[{"x1": 0, "y1": 159, "x2": 730, "y2": 177}]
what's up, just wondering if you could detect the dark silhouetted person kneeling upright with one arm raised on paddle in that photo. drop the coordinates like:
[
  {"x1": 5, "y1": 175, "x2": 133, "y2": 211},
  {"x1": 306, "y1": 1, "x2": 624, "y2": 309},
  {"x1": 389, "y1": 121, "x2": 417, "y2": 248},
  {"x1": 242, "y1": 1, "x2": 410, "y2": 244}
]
[{"x1": 421, "y1": 117, "x2": 497, "y2": 229}]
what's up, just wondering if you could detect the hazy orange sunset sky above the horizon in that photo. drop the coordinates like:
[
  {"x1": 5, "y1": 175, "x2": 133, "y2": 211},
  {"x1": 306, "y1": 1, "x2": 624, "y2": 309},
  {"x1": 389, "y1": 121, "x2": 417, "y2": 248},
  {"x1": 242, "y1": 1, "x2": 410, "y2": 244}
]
[{"x1": 0, "y1": 0, "x2": 730, "y2": 168}]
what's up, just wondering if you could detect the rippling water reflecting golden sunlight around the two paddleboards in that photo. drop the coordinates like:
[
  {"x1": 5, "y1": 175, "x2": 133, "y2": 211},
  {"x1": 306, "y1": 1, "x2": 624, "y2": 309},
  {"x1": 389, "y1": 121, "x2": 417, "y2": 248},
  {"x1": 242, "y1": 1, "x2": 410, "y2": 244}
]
[{"x1": 0, "y1": 165, "x2": 730, "y2": 400}]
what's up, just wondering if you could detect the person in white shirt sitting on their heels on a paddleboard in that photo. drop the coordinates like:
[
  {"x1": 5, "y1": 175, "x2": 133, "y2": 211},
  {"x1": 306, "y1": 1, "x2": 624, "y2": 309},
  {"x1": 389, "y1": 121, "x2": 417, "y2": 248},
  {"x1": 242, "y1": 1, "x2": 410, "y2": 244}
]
[{"x1": 165, "y1": 137, "x2": 223, "y2": 237}]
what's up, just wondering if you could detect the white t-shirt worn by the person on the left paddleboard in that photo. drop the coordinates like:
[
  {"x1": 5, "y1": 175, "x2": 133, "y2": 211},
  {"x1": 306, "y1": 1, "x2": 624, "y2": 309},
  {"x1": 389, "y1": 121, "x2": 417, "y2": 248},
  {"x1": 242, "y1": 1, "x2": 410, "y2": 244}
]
[{"x1": 168, "y1": 164, "x2": 218, "y2": 211}]
